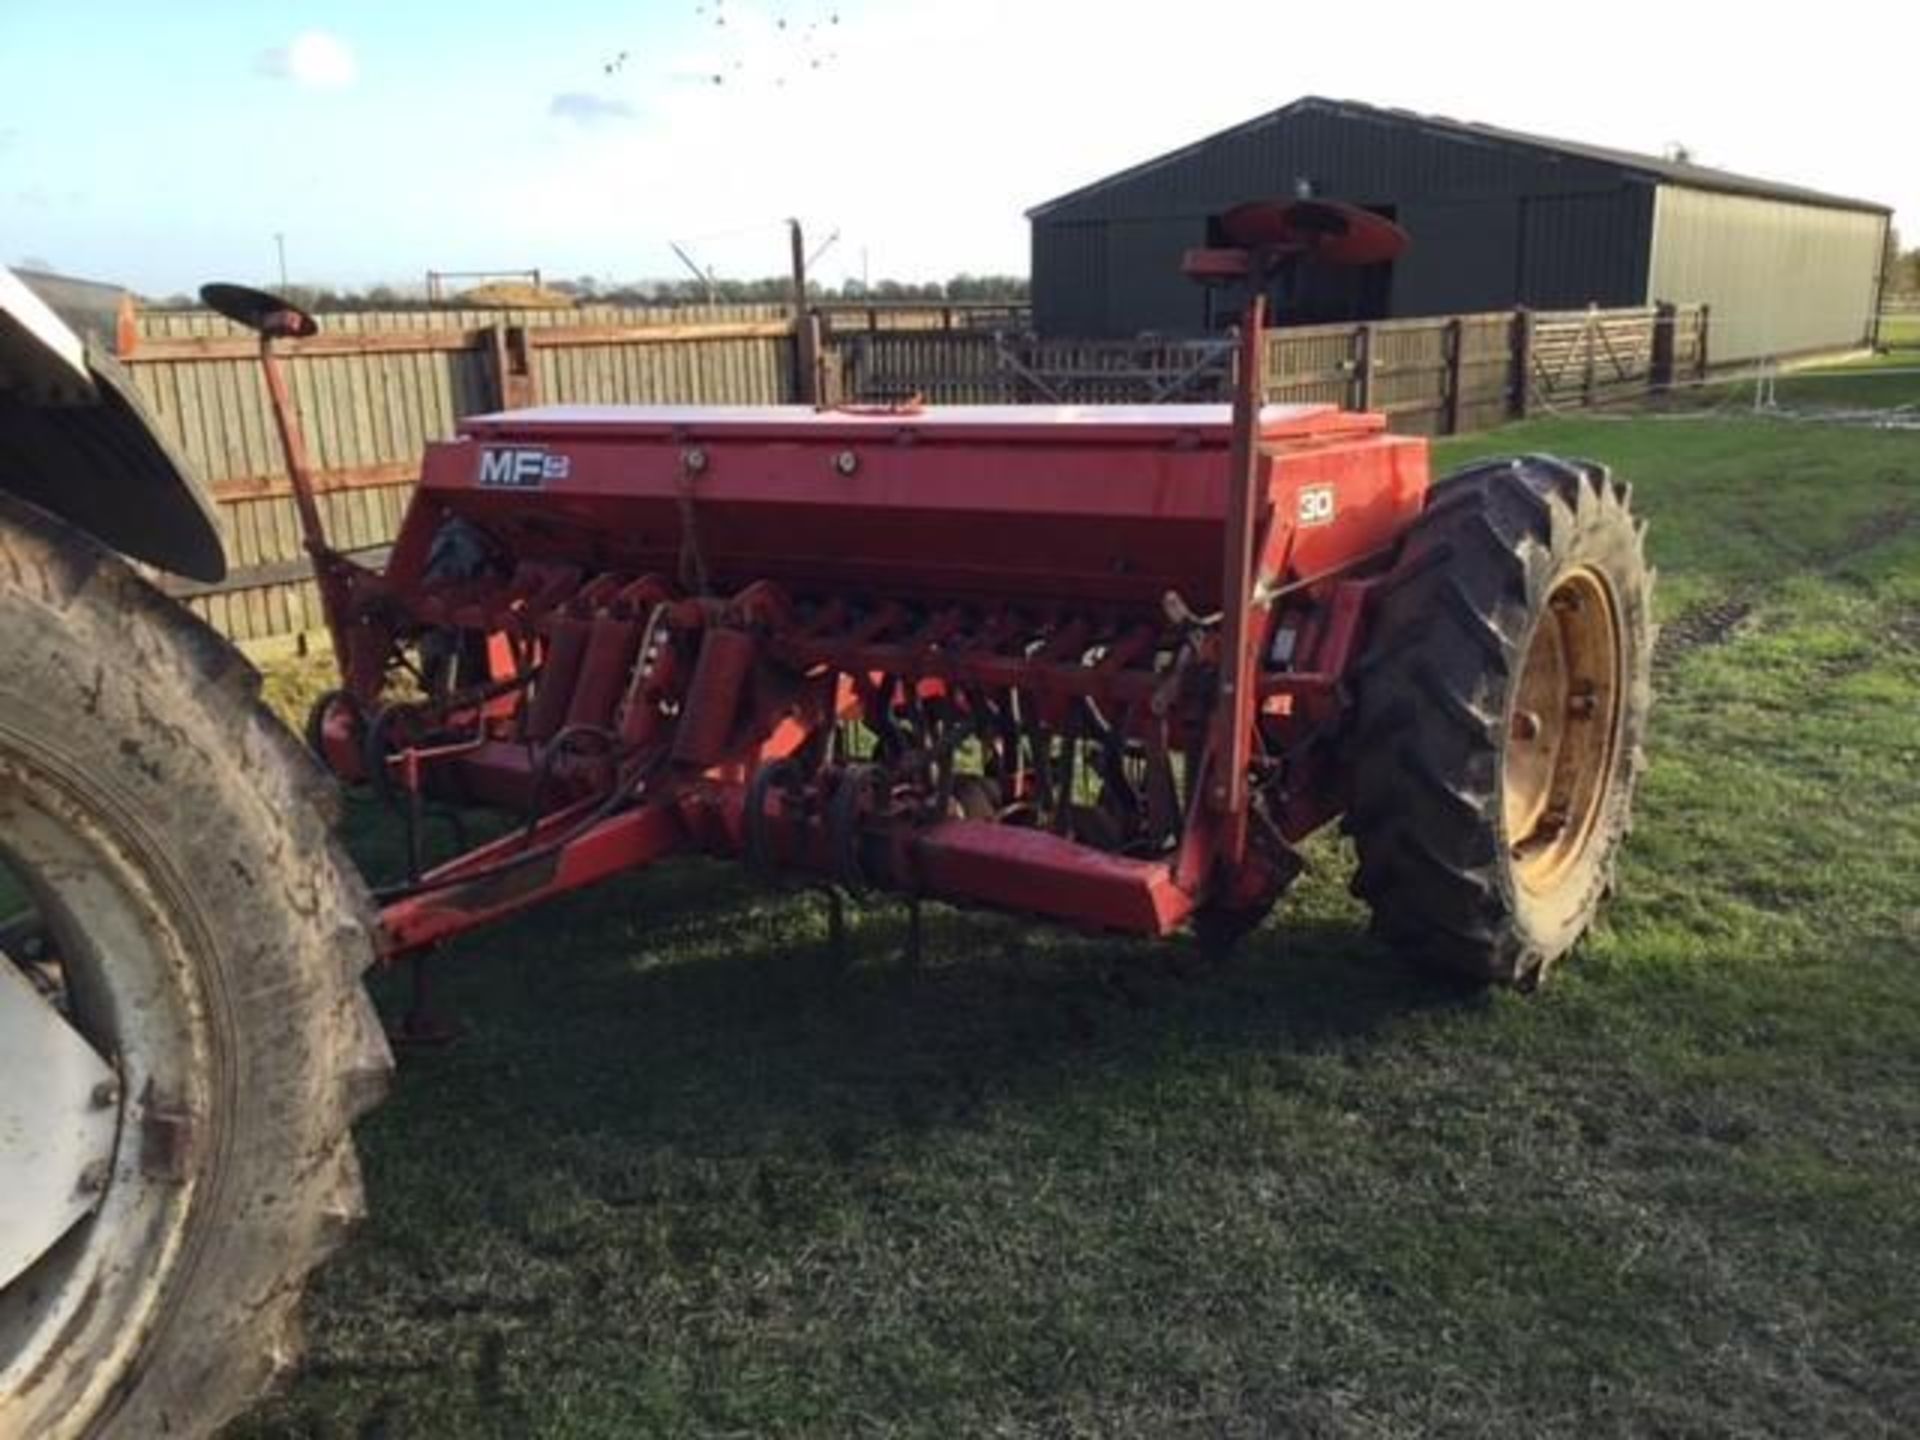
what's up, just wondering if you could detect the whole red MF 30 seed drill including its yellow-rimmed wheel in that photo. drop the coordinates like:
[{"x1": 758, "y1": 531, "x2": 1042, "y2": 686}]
[{"x1": 209, "y1": 202, "x2": 1647, "y2": 981}]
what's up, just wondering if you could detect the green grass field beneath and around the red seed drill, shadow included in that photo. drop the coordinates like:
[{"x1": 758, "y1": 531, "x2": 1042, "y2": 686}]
[{"x1": 240, "y1": 391, "x2": 1920, "y2": 1440}]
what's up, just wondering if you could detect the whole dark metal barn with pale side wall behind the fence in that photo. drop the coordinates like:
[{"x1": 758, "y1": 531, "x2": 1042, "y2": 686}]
[{"x1": 1027, "y1": 96, "x2": 1889, "y2": 359}]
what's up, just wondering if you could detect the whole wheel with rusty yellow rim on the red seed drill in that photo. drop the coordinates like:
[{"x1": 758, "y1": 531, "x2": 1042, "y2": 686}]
[{"x1": 1346, "y1": 455, "x2": 1653, "y2": 985}]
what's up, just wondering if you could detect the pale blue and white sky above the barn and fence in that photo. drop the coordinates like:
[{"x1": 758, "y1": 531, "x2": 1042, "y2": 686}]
[{"x1": 0, "y1": 0, "x2": 1920, "y2": 294}]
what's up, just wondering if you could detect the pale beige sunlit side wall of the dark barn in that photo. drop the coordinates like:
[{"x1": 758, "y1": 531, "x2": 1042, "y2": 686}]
[{"x1": 1647, "y1": 184, "x2": 1887, "y2": 365}]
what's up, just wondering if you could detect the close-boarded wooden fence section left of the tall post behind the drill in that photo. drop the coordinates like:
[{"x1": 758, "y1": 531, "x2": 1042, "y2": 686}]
[{"x1": 121, "y1": 307, "x2": 801, "y2": 641}]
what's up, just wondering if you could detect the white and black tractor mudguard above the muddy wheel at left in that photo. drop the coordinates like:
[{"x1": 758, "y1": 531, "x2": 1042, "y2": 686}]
[{"x1": 0, "y1": 267, "x2": 227, "y2": 580}]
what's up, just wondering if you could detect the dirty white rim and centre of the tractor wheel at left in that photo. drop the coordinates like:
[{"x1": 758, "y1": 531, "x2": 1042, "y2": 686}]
[{"x1": 0, "y1": 783, "x2": 205, "y2": 1436}]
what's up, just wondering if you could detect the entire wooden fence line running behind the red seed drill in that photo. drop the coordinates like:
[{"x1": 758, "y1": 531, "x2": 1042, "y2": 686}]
[{"x1": 121, "y1": 305, "x2": 1709, "y2": 641}]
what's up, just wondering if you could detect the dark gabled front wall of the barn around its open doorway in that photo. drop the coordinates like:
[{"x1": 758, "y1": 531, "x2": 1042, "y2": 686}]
[{"x1": 1033, "y1": 108, "x2": 1653, "y2": 338}]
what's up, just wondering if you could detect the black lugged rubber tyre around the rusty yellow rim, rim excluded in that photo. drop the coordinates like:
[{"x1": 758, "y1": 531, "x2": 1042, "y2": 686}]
[{"x1": 1342, "y1": 455, "x2": 1651, "y2": 985}]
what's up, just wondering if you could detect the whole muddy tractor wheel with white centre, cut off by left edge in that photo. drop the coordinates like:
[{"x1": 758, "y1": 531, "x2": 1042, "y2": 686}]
[{"x1": 0, "y1": 497, "x2": 392, "y2": 1440}]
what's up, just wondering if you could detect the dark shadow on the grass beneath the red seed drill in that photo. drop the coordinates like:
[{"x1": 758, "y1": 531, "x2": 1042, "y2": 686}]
[{"x1": 349, "y1": 821, "x2": 1484, "y2": 1223}]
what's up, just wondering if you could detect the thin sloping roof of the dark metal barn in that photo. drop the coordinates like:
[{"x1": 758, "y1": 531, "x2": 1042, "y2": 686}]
[{"x1": 1027, "y1": 96, "x2": 1893, "y2": 219}]
